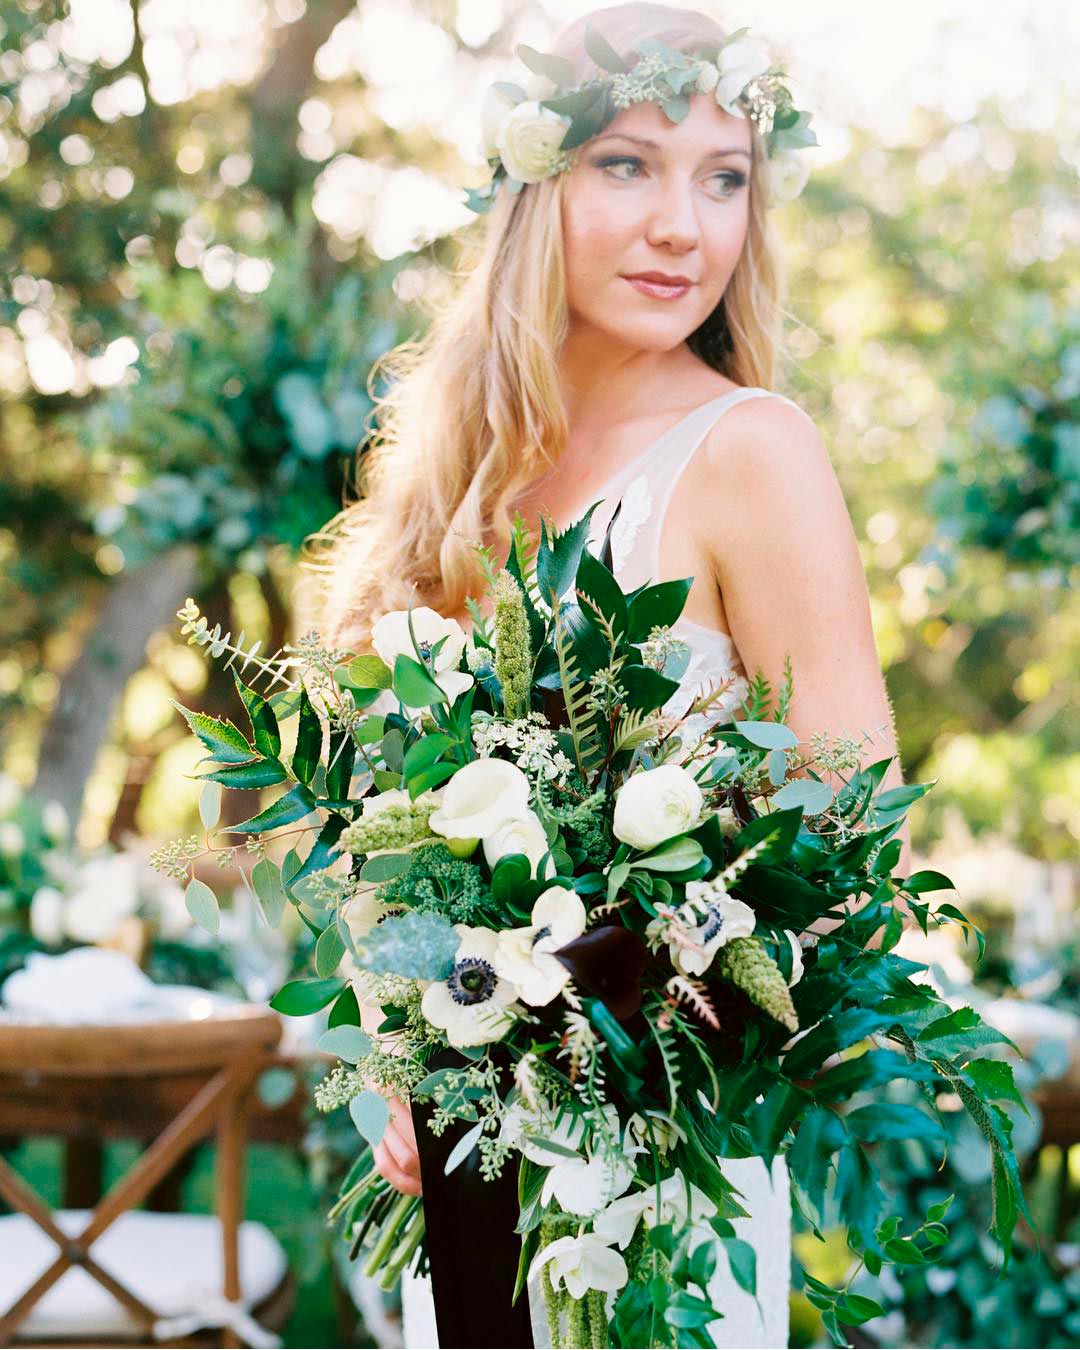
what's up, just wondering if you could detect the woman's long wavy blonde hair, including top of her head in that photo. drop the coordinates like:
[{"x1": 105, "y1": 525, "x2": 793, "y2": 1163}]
[{"x1": 297, "y1": 3, "x2": 784, "y2": 652}]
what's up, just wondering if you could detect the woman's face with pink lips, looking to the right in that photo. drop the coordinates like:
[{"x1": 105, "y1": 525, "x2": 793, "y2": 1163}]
[{"x1": 562, "y1": 93, "x2": 751, "y2": 351}]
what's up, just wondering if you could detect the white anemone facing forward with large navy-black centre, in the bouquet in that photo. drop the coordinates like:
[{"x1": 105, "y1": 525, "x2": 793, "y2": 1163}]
[{"x1": 420, "y1": 923, "x2": 520, "y2": 1049}]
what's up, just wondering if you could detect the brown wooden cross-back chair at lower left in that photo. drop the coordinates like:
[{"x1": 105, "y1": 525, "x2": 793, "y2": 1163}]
[{"x1": 0, "y1": 1004, "x2": 292, "y2": 1346}]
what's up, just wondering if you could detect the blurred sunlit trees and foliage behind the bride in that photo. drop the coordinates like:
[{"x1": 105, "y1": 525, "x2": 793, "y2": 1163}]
[{"x1": 0, "y1": 0, "x2": 1080, "y2": 1346}]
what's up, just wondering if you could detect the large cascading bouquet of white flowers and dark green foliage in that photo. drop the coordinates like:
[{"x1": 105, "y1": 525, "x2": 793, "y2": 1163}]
[{"x1": 160, "y1": 512, "x2": 1026, "y2": 1346}]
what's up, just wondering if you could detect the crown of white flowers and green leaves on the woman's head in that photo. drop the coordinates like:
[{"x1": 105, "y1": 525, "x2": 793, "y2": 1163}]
[{"x1": 466, "y1": 23, "x2": 818, "y2": 215}]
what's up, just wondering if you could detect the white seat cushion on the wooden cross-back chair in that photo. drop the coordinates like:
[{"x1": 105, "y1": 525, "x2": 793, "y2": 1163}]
[{"x1": 0, "y1": 1210, "x2": 288, "y2": 1339}]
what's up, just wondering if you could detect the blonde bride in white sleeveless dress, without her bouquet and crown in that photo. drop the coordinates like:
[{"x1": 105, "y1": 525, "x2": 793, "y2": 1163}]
[{"x1": 306, "y1": 4, "x2": 909, "y2": 1347}]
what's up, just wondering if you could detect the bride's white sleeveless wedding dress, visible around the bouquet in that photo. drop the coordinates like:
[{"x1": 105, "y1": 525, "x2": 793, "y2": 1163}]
[{"x1": 402, "y1": 386, "x2": 805, "y2": 1350}]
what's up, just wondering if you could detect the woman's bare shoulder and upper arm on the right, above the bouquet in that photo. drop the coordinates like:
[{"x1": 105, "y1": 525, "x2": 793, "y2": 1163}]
[{"x1": 701, "y1": 398, "x2": 911, "y2": 945}]
